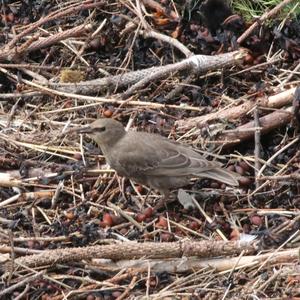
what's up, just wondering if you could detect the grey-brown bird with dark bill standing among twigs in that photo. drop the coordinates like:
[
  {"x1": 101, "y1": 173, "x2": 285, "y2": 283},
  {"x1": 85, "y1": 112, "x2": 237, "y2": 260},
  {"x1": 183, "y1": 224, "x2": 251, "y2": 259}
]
[{"x1": 77, "y1": 118, "x2": 239, "y2": 204}]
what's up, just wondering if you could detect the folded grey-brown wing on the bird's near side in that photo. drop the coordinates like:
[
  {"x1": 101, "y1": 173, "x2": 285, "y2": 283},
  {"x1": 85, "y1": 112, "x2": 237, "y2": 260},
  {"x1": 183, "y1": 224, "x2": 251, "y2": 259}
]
[{"x1": 112, "y1": 133, "x2": 221, "y2": 177}]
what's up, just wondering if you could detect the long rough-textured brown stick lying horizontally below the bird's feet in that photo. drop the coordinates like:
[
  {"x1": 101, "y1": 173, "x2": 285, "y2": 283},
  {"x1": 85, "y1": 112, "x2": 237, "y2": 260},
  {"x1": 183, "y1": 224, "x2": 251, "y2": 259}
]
[{"x1": 2, "y1": 241, "x2": 256, "y2": 272}]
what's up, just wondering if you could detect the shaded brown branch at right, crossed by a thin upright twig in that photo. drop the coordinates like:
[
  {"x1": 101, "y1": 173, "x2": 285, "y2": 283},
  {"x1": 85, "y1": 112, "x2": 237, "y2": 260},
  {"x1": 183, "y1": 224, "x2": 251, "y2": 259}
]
[{"x1": 217, "y1": 107, "x2": 294, "y2": 146}]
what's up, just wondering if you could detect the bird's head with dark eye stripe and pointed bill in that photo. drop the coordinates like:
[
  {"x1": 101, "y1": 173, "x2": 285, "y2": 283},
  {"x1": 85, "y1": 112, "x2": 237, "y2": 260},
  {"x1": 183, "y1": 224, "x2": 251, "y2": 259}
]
[{"x1": 78, "y1": 119, "x2": 126, "y2": 147}]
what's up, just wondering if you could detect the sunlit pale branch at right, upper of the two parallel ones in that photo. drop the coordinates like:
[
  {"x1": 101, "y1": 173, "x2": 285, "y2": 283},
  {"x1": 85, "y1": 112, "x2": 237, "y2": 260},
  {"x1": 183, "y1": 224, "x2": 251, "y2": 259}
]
[{"x1": 176, "y1": 88, "x2": 296, "y2": 130}]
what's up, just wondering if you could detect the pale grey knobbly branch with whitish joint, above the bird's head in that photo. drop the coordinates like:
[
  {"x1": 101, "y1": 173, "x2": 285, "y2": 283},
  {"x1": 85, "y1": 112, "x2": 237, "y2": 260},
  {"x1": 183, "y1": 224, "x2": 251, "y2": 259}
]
[{"x1": 48, "y1": 49, "x2": 246, "y2": 95}]
